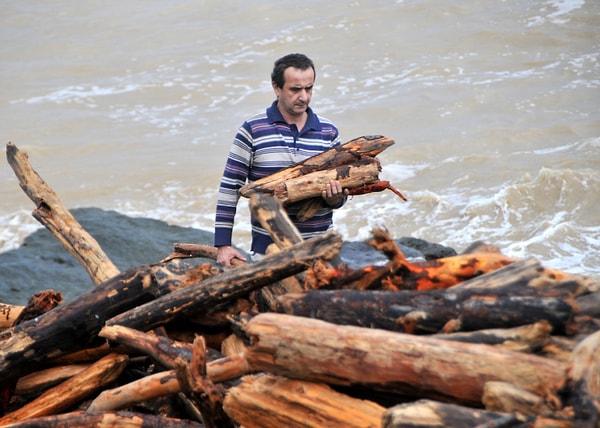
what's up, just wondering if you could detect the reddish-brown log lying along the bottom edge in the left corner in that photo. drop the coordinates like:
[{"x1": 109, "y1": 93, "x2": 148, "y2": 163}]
[{"x1": 0, "y1": 411, "x2": 204, "y2": 428}]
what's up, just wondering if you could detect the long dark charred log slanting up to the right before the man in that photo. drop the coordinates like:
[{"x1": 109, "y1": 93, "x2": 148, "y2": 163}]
[{"x1": 106, "y1": 232, "x2": 342, "y2": 331}]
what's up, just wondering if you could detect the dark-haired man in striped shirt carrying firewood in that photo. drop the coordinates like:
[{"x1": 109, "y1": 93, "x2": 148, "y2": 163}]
[{"x1": 215, "y1": 54, "x2": 348, "y2": 266}]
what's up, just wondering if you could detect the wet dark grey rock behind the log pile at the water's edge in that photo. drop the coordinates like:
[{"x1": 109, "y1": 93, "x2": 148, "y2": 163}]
[{"x1": 0, "y1": 208, "x2": 456, "y2": 305}]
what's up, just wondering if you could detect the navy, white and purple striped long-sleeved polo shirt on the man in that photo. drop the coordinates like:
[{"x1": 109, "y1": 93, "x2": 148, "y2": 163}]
[{"x1": 214, "y1": 101, "x2": 341, "y2": 254}]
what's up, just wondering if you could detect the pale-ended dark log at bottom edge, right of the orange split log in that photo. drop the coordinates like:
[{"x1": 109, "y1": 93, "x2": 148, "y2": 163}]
[{"x1": 381, "y1": 400, "x2": 528, "y2": 428}]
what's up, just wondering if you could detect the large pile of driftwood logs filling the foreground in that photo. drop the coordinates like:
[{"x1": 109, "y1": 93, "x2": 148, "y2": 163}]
[{"x1": 0, "y1": 143, "x2": 600, "y2": 428}]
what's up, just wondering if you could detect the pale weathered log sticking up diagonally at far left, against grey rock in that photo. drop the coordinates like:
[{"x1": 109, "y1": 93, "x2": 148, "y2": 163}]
[{"x1": 6, "y1": 142, "x2": 119, "y2": 285}]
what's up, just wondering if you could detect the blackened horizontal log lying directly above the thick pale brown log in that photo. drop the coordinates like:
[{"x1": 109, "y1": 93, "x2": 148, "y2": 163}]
[{"x1": 278, "y1": 287, "x2": 574, "y2": 334}]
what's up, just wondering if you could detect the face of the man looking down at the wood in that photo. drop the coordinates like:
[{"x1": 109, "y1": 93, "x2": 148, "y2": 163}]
[{"x1": 273, "y1": 67, "x2": 315, "y2": 116}]
